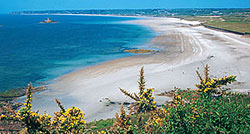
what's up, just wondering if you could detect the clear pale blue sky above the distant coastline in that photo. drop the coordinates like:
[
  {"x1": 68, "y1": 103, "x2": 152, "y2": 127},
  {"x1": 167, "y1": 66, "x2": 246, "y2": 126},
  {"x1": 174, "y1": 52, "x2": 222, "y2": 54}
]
[{"x1": 0, "y1": 0, "x2": 250, "y2": 13}]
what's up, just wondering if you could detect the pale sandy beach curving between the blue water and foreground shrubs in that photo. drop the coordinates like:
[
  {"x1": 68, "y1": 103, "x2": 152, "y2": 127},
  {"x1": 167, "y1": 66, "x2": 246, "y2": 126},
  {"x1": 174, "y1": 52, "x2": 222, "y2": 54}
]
[{"x1": 30, "y1": 17, "x2": 250, "y2": 121}]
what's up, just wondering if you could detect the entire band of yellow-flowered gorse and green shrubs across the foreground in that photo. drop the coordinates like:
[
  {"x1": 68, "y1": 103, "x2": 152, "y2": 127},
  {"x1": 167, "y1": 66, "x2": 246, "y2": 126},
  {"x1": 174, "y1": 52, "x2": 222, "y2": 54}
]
[{"x1": 0, "y1": 66, "x2": 250, "y2": 134}]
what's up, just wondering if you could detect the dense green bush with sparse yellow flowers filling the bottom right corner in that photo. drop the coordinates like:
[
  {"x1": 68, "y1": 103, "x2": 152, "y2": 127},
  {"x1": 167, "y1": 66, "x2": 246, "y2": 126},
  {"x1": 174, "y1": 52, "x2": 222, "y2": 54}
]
[{"x1": 133, "y1": 66, "x2": 250, "y2": 133}]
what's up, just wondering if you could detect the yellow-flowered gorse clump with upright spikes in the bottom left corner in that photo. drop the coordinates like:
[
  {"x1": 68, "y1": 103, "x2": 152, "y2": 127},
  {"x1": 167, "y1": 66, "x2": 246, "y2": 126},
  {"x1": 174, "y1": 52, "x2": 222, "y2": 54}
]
[{"x1": 0, "y1": 84, "x2": 86, "y2": 134}]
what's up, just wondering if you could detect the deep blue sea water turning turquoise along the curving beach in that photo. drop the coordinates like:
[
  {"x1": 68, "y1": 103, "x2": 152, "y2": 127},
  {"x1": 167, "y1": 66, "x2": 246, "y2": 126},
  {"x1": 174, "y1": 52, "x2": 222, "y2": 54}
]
[{"x1": 0, "y1": 15, "x2": 155, "y2": 91}]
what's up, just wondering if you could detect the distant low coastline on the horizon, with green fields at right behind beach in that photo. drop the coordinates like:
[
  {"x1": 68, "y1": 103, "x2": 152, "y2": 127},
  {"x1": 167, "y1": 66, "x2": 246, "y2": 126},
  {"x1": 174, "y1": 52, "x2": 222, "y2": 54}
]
[{"x1": 9, "y1": 8, "x2": 250, "y2": 36}]
